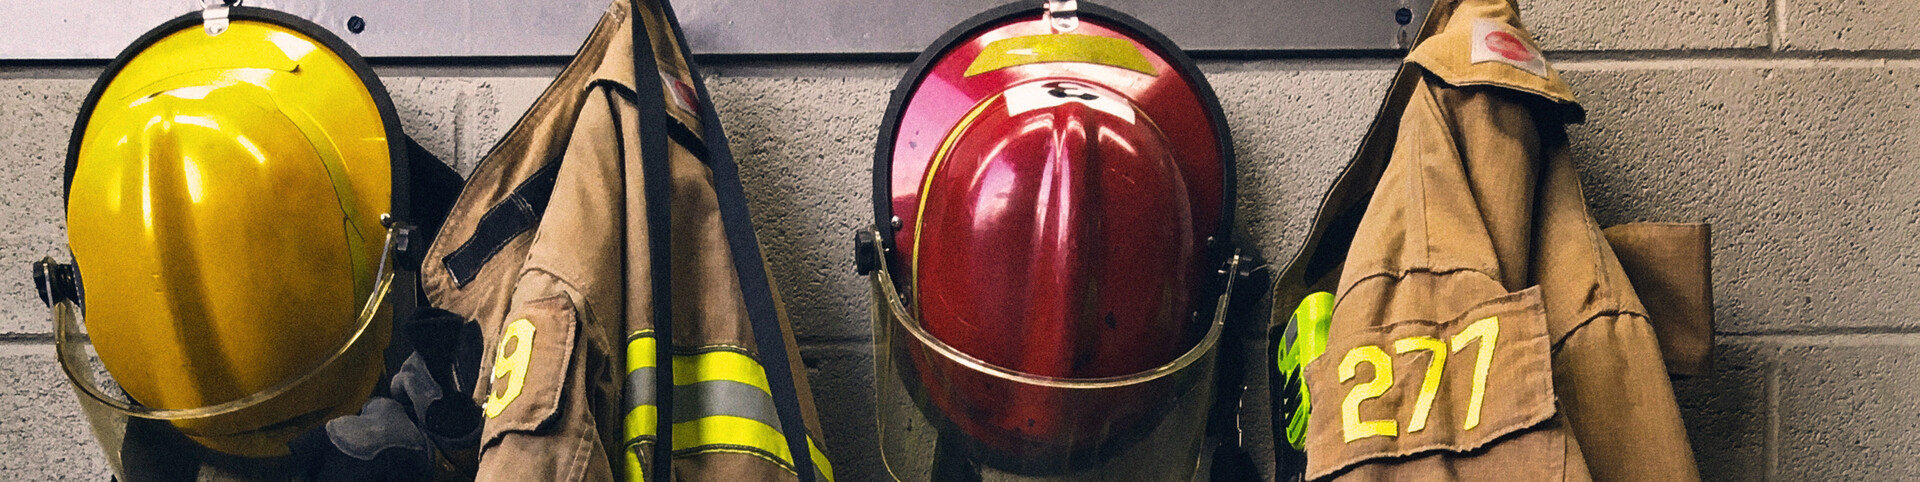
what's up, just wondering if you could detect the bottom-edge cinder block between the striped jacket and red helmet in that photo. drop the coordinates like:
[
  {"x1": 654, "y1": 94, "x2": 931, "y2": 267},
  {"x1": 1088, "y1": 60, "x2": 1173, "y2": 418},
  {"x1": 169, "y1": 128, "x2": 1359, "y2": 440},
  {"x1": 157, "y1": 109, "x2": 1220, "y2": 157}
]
[{"x1": 801, "y1": 344, "x2": 889, "y2": 480}]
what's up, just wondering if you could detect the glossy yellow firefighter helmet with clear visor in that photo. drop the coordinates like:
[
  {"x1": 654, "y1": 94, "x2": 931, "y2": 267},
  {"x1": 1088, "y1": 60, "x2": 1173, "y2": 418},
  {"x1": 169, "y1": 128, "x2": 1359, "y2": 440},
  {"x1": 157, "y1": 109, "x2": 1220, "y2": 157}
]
[{"x1": 42, "y1": 8, "x2": 407, "y2": 462}]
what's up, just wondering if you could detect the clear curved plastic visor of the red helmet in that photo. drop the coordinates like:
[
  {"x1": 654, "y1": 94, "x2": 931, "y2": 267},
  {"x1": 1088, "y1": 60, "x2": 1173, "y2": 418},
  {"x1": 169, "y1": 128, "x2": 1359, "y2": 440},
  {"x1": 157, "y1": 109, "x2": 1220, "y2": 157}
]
[{"x1": 862, "y1": 230, "x2": 1238, "y2": 480}]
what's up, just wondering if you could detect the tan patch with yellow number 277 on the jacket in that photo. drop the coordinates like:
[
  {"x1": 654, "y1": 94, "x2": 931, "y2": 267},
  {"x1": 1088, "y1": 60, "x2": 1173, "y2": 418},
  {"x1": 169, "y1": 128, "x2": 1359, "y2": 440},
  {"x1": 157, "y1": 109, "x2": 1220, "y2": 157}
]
[{"x1": 1308, "y1": 290, "x2": 1553, "y2": 457}]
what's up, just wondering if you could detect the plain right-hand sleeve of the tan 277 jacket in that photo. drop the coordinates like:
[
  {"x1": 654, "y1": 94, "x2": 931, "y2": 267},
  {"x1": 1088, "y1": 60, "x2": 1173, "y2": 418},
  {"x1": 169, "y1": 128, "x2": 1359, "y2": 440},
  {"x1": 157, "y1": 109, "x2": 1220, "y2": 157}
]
[{"x1": 1532, "y1": 135, "x2": 1699, "y2": 480}]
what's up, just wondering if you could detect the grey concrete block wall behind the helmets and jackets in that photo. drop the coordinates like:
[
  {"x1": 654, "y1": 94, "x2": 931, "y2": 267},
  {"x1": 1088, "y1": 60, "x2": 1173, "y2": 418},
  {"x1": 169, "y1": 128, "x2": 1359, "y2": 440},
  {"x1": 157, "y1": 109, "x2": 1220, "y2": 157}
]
[{"x1": 0, "y1": 0, "x2": 1920, "y2": 480}]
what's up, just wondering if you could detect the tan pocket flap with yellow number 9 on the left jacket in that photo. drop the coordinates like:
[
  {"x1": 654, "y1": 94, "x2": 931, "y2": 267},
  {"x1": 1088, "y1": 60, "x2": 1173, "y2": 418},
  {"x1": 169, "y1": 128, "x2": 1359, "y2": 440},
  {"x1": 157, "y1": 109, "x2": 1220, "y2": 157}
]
[{"x1": 480, "y1": 296, "x2": 578, "y2": 449}]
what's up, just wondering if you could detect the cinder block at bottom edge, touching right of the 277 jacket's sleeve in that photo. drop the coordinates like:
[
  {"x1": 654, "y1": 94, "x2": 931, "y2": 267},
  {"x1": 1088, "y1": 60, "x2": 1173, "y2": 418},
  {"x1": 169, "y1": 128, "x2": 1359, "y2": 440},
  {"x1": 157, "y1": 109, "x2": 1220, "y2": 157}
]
[{"x1": 1674, "y1": 338, "x2": 1780, "y2": 480}]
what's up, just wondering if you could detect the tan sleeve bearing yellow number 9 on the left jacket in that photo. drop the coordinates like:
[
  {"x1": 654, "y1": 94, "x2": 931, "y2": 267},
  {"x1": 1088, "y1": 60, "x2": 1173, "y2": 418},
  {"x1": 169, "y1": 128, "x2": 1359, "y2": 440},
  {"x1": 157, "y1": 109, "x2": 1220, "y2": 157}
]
[{"x1": 474, "y1": 90, "x2": 632, "y2": 480}]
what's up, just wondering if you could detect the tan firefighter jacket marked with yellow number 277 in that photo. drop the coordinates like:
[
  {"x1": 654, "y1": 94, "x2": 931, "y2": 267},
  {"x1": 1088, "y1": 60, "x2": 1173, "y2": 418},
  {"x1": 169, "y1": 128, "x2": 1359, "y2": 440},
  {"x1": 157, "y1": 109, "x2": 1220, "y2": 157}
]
[{"x1": 1275, "y1": 0, "x2": 1711, "y2": 480}]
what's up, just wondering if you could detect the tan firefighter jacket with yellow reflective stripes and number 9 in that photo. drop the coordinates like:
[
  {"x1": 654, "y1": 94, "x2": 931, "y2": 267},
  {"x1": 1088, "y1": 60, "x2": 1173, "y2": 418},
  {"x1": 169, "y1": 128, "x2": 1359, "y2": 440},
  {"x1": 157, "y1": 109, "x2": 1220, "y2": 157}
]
[{"x1": 420, "y1": 0, "x2": 833, "y2": 482}]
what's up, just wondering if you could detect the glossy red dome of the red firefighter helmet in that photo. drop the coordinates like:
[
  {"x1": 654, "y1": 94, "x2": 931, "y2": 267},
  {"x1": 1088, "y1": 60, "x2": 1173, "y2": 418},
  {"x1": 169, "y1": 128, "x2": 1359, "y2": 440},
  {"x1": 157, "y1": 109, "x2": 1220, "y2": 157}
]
[{"x1": 912, "y1": 79, "x2": 1200, "y2": 378}]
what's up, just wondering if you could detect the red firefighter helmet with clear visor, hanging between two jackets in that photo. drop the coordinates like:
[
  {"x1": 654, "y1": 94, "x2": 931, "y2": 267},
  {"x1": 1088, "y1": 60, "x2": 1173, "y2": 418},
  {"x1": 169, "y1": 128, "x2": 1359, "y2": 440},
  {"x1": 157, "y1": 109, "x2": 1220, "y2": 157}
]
[{"x1": 876, "y1": 4, "x2": 1233, "y2": 470}]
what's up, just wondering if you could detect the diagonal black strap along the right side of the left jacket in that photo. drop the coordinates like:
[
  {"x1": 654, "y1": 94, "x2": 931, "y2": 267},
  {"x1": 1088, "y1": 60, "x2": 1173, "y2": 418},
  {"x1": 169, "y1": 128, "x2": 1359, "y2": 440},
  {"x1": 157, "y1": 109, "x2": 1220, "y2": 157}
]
[{"x1": 656, "y1": 0, "x2": 816, "y2": 482}]
